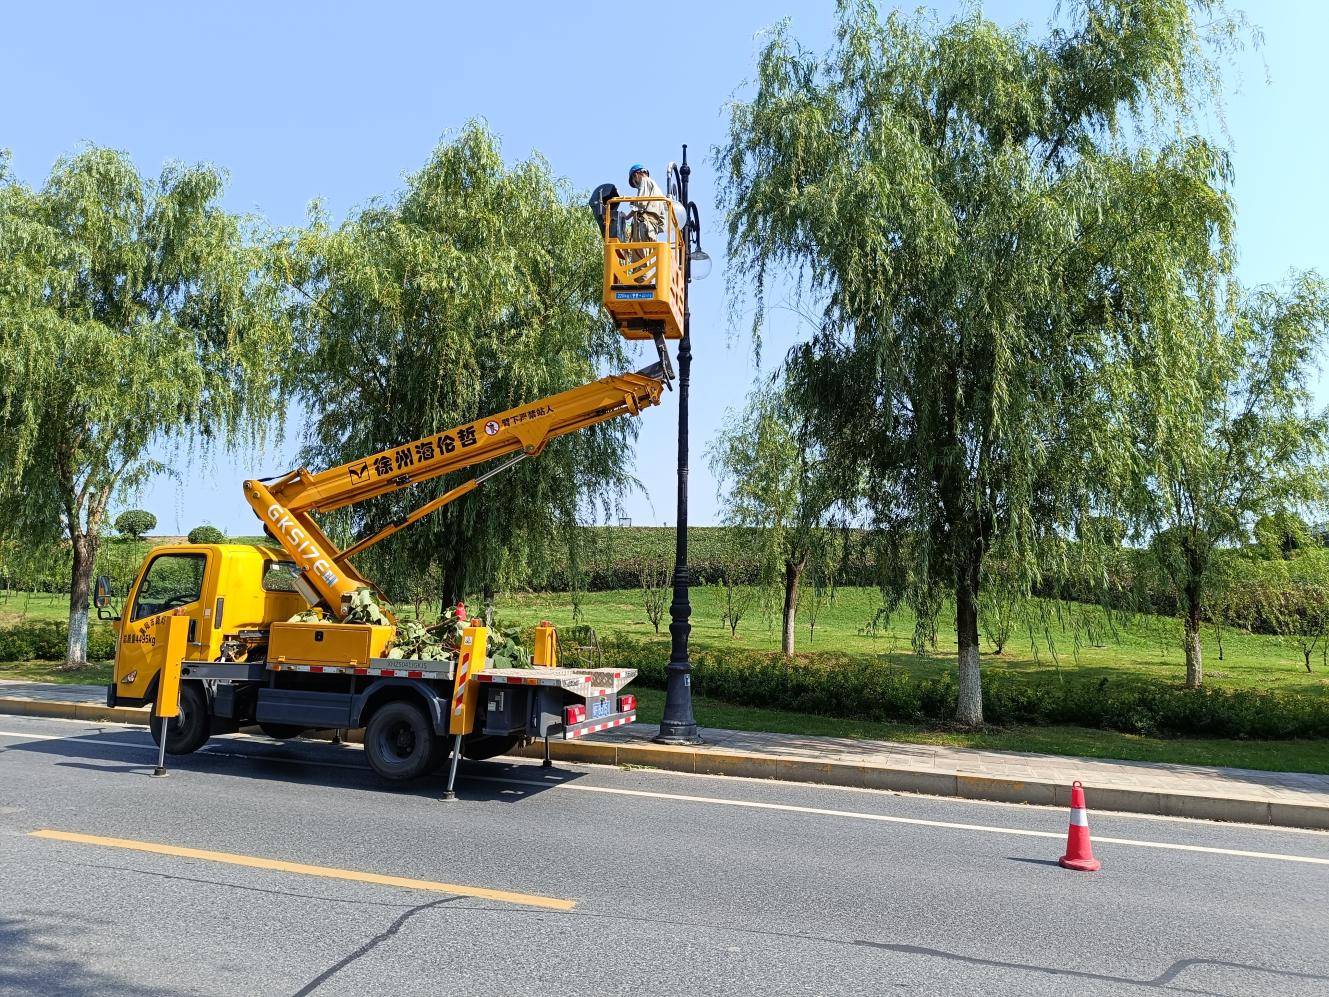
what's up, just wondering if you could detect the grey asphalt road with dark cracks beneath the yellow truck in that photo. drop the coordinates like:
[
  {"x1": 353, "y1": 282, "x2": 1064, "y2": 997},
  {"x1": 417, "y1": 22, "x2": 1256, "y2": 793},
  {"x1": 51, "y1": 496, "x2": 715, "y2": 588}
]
[{"x1": 0, "y1": 717, "x2": 1329, "y2": 997}]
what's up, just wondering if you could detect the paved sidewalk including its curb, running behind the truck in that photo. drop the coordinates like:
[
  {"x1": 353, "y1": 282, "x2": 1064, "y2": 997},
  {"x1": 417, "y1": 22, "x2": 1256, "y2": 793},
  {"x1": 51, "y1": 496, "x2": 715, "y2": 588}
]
[{"x1": 0, "y1": 679, "x2": 1329, "y2": 830}]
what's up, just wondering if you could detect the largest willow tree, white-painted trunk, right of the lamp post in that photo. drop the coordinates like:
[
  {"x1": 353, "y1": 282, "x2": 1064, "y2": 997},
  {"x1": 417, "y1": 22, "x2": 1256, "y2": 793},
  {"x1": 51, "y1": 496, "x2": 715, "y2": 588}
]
[{"x1": 716, "y1": 0, "x2": 1235, "y2": 723}]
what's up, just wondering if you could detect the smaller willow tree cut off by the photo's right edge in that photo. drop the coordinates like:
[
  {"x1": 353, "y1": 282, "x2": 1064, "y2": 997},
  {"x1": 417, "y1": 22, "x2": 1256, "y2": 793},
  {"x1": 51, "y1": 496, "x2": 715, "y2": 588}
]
[{"x1": 1128, "y1": 274, "x2": 1329, "y2": 689}]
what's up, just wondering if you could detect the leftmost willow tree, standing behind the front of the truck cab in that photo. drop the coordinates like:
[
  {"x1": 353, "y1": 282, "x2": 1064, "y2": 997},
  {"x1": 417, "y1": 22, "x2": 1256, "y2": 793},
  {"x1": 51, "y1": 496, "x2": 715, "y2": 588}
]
[{"x1": 0, "y1": 148, "x2": 288, "y2": 666}]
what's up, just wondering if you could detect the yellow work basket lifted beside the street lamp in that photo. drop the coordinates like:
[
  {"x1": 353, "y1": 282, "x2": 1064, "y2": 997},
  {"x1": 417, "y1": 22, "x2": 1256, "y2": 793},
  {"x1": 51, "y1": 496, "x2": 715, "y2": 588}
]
[{"x1": 603, "y1": 197, "x2": 687, "y2": 339}]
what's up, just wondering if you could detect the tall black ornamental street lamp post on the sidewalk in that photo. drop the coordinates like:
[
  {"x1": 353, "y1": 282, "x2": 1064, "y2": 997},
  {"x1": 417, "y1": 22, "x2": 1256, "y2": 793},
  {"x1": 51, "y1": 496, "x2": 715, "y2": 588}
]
[{"x1": 655, "y1": 145, "x2": 708, "y2": 744}]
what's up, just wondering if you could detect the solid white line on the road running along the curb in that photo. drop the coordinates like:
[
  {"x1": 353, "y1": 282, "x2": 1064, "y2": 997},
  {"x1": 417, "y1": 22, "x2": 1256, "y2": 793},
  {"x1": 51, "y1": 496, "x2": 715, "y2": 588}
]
[{"x1": 0, "y1": 731, "x2": 1329, "y2": 865}]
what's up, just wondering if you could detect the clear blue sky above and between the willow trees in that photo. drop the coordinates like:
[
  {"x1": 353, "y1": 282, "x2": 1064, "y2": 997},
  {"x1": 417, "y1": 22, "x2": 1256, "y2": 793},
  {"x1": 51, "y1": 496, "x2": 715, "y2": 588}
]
[{"x1": 0, "y1": 0, "x2": 1329, "y2": 533}]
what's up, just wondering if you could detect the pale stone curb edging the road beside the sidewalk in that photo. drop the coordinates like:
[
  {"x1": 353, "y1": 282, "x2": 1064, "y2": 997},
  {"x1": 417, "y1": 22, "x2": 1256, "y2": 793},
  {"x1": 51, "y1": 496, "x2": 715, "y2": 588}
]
[{"x1": 0, "y1": 697, "x2": 1329, "y2": 831}]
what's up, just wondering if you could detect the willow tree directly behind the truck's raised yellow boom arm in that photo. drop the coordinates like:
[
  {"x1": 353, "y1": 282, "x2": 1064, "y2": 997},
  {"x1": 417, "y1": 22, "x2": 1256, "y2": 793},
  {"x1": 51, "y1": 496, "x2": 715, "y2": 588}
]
[{"x1": 283, "y1": 124, "x2": 632, "y2": 601}]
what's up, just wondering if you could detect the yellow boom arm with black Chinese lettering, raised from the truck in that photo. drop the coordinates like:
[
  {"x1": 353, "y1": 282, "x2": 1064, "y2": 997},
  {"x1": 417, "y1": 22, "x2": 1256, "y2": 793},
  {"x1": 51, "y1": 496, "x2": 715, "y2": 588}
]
[{"x1": 245, "y1": 363, "x2": 668, "y2": 618}]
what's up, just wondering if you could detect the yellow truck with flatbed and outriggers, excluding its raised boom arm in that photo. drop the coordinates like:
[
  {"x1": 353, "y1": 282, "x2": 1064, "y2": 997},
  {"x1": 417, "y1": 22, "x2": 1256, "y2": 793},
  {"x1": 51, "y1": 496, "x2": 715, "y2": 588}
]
[{"x1": 96, "y1": 544, "x2": 637, "y2": 791}]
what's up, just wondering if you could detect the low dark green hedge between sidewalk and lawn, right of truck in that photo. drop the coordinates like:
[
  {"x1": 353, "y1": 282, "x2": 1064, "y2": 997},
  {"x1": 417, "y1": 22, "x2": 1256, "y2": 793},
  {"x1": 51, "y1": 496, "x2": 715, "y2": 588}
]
[{"x1": 603, "y1": 637, "x2": 1329, "y2": 740}]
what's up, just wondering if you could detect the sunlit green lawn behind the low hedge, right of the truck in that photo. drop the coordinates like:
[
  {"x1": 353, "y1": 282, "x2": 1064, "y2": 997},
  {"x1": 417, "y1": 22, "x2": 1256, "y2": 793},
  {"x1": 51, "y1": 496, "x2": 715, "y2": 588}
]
[{"x1": 497, "y1": 586, "x2": 1329, "y2": 695}]
